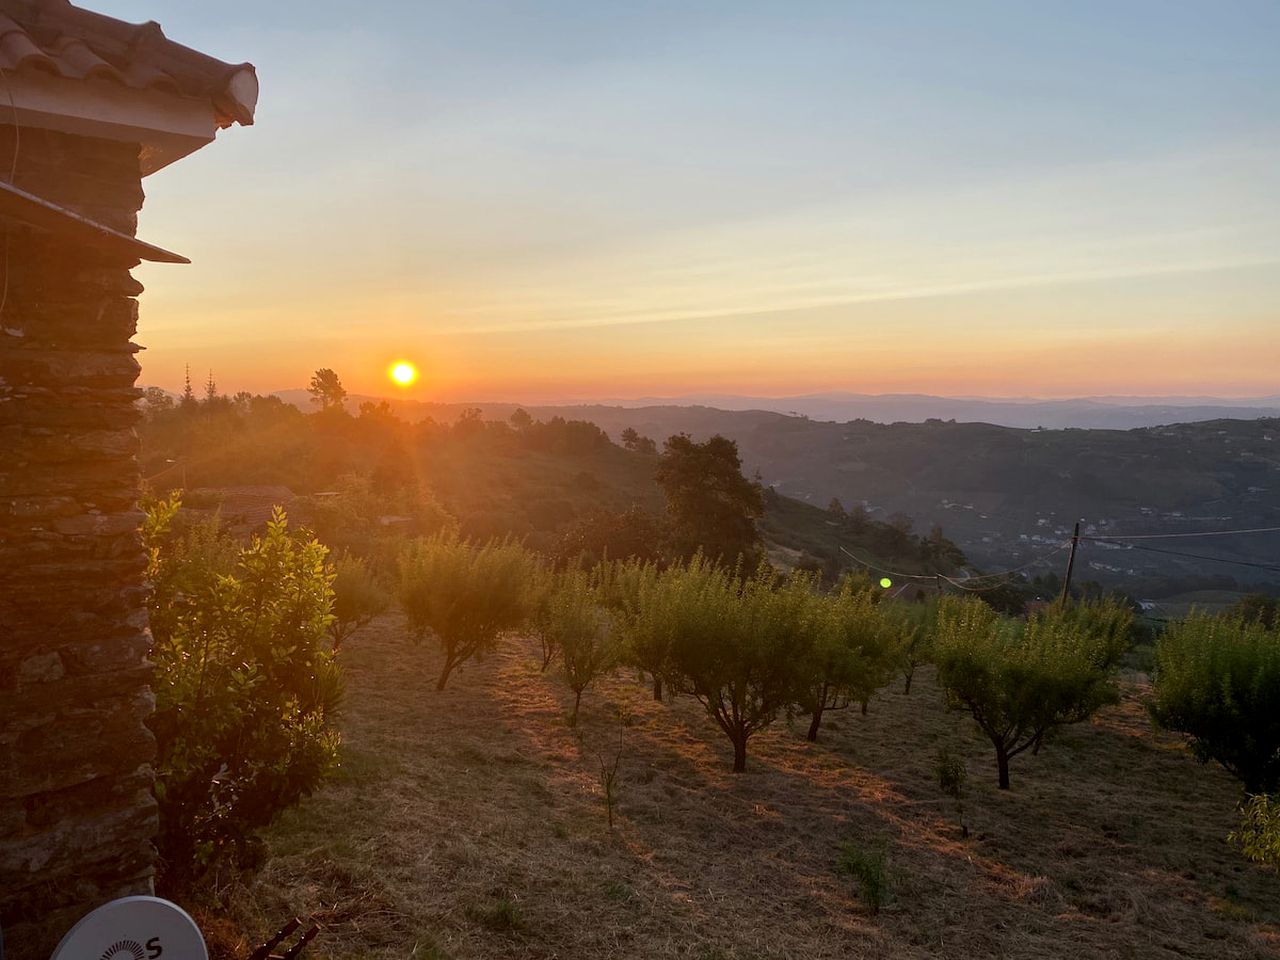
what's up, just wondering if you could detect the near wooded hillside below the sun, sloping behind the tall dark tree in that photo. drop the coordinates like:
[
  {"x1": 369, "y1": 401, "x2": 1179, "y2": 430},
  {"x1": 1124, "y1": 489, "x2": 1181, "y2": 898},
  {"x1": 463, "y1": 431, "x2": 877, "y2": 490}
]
[{"x1": 140, "y1": 397, "x2": 956, "y2": 576}]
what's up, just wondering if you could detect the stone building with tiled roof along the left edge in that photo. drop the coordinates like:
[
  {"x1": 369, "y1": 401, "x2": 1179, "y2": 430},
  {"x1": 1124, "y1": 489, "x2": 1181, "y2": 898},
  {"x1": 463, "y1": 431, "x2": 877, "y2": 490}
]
[{"x1": 0, "y1": 0, "x2": 257, "y2": 960}]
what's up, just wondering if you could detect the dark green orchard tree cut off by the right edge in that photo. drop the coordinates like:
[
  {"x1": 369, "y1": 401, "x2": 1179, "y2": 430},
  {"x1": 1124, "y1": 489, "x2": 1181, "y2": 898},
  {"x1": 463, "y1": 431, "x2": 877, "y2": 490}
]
[{"x1": 1151, "y1": 613, "x2": 1280, "y2": 794}]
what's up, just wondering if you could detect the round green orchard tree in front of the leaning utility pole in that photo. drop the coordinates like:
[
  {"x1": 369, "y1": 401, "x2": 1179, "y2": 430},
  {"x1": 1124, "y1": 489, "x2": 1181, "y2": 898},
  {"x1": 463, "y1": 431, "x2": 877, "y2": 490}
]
[{"x1": 934, "y1": 598, "x2": 1132, "y2": 790}]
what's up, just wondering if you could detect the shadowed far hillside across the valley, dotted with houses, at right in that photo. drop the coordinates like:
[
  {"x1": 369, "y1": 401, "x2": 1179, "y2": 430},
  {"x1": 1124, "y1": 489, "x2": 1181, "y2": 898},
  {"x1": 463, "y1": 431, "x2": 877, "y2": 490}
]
[{"x1": 509, "y1": 407, "x2": 1280, "y2": 589}]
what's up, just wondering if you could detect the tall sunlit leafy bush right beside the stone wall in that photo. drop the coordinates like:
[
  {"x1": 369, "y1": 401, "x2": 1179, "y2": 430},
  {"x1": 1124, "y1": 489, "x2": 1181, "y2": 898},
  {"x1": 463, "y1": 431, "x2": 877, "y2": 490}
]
[{"x1": 143, "y1": 497, "x2": 342, "y2": 888}]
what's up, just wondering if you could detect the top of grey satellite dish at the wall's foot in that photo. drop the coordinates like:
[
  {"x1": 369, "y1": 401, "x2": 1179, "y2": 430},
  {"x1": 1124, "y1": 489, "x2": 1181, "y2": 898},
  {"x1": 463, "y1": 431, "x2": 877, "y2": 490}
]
[{"x1": 51, "y1": 897, "x2": 209, "y2": 960}]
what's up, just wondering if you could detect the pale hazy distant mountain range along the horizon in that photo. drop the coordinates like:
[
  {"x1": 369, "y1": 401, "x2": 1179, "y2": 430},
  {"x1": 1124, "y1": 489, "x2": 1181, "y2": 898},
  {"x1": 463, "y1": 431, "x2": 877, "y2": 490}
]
[{"x1": 278, "y1": 390, "x2": 1280, "y2": 430}]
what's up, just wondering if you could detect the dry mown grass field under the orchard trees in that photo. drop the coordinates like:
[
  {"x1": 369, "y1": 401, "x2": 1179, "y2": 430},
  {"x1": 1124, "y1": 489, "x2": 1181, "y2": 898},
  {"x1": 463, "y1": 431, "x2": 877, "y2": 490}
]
[{"x1": 202, "y1": 617, "x2": 1280, "y2": 960}]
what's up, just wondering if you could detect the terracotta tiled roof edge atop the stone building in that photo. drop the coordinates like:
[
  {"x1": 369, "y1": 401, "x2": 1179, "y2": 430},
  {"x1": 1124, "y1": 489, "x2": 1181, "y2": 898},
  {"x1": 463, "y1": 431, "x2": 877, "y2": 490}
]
[{"x1": 0, "y1": 0, "x2": 257, "y2": 127}]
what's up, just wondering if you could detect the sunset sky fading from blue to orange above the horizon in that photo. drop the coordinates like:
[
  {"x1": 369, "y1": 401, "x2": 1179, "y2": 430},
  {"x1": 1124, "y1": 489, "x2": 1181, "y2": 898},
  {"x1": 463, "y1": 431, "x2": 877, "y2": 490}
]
[{"x1": 97, "y1": 0, "x2": 1280, "y2": 402}]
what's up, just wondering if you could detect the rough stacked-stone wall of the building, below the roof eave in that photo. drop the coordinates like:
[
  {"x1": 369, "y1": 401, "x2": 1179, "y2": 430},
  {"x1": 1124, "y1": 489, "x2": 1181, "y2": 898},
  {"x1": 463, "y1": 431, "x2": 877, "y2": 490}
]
[{"x1": 0, "y1": 127, "x2": 156, "y2": 960}]
